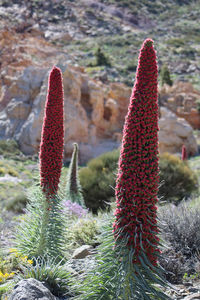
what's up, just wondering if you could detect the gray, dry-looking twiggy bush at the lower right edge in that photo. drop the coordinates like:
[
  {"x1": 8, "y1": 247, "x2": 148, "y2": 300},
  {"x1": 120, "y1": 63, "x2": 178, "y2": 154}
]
[{"x1": 159, "y1": 201, "x2": 200, "y2": 283}]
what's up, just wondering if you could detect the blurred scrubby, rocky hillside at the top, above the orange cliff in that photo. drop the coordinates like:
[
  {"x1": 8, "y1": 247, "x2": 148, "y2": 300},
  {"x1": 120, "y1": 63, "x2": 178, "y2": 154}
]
[{"x1": 0, "y1": 0, "x2": 200, "y2": 86}]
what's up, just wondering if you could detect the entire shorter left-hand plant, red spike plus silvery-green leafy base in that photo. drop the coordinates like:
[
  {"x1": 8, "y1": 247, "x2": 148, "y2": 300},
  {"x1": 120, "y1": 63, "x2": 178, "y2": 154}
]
[{"x1": 17, "y1": 67, "x2": 64, "y2": 257}]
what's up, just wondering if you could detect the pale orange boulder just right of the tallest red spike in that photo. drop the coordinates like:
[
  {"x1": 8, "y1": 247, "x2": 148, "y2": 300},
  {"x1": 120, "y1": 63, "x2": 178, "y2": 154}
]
[{"x1": 159, "y1": 107, "x2": 198, "y2": 155}]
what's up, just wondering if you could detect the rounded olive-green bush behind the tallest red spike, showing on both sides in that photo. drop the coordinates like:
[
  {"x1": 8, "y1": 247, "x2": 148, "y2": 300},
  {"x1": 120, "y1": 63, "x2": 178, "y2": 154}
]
[{"x1": 79, "y1": 150, "x2": 198, "y2": 213}]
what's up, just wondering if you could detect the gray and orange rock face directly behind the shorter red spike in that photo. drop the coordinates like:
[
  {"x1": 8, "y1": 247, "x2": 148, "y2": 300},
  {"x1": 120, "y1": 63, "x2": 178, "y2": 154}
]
[{"x1": 0, "y1": 65, "x2": 131, "y2": 162}]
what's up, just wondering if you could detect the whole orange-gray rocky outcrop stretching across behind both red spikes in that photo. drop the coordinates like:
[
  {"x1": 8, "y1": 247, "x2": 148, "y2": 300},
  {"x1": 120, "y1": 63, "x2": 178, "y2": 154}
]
[{"x1": 0, "y1": 28, "x2": 199, "y2": 163}]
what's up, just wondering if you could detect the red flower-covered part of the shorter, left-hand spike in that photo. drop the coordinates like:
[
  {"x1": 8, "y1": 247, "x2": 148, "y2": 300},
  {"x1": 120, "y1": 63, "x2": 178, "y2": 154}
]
[{"x1": 39, "y1": 67, "x2": 64, "y2": 195}]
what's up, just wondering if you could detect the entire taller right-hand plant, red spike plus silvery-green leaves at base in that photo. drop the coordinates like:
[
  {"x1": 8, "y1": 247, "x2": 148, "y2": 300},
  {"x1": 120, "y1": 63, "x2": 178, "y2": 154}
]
[{"x1": 77, "y1": 39, "x2": 169, "y2": 300}]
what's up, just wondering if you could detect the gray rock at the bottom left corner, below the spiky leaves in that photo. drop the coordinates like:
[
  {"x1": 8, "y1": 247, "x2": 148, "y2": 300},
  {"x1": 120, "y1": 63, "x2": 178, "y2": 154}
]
[{"x1": 8, "y1": 278, "x2": 57, "y2": 300}]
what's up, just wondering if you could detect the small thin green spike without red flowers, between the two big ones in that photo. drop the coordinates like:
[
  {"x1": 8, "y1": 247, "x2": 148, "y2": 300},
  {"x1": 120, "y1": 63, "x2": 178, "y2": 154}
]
[{"x1": 66, "y1": 143, "x2": 85, "y2": 207}]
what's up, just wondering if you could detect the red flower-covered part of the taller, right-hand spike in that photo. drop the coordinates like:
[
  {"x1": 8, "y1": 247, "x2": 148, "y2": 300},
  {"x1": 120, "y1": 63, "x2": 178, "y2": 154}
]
[{"x1": 113, "y1": 39, "x2": 159, "y2": 265}]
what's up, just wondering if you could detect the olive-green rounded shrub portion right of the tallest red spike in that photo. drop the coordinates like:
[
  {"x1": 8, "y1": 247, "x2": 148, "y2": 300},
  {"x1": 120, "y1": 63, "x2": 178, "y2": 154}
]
[{"x1": 158, "y1": 153, "x2": 198, "y2": 203}]
